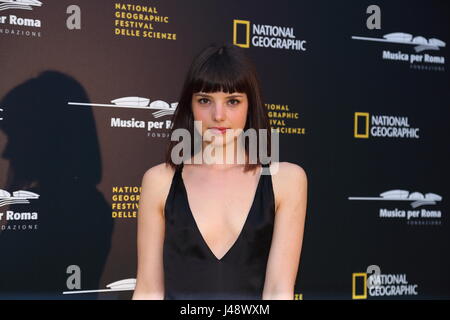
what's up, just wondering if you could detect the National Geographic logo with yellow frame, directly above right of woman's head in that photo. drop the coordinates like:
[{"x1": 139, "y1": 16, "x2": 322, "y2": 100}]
[{"x1": 233, "y1": 19, "x2": 306, "y2": 51}]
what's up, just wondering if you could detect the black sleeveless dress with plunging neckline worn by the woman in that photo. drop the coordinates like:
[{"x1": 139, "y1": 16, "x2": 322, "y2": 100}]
[{"x1": 163, "y1": 165, "x2": 275, "y2": 300}]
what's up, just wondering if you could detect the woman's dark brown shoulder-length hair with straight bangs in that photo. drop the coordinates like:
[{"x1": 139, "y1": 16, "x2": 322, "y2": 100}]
[{"x1": 165, "y1": 44, "x2": 271, "y2": 171}]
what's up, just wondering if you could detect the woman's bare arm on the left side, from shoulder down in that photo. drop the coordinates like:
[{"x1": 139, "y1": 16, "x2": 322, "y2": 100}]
[{"x1": 132, "y1": 163, "x2": 170, "y2": 300}]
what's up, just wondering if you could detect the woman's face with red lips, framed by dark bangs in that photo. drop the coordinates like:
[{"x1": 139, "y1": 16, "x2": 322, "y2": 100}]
[{"x1": 192, "y1": 91, "x2": 248, "y2": 144}]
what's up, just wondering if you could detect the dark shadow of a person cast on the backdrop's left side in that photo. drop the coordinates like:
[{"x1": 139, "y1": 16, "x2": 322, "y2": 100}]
[{"x1": 0, "y1": 71, "x2": 113, "y2": 299}]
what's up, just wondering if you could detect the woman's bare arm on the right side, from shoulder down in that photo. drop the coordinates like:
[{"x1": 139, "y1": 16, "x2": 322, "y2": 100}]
[{"x1": 262, "y1": 162, "x2": 308, "y2": 300}]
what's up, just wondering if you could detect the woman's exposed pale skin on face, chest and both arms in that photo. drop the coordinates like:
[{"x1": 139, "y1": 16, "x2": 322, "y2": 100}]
[{"x1": 133, "y1": 92, "x2": 307, "y2": 300}]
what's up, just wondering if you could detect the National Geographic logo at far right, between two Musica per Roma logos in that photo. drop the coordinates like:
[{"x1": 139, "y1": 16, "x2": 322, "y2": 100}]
[{"x1": 354, "y1": 112, "x2": 420, "y2": 139}]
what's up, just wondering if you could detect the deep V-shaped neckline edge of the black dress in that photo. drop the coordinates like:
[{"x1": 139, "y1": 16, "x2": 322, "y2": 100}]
[{"x1": 180, "y1": 164, "x2": 264, "y2": 262}]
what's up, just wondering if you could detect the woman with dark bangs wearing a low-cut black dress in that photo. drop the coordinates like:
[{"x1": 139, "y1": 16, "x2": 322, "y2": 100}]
[{"x1": 133, "y1": 45, "x2": 307, "y2": 299}]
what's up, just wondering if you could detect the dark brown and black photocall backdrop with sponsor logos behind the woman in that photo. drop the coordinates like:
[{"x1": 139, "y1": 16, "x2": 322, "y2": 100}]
[{"x1": 0, "y1": 0, "x2": 450, "y2": 300}]
